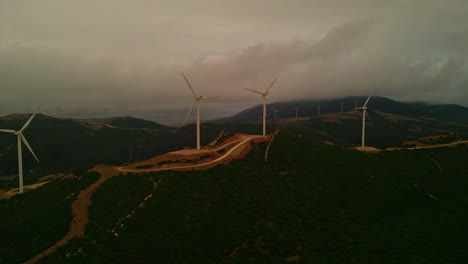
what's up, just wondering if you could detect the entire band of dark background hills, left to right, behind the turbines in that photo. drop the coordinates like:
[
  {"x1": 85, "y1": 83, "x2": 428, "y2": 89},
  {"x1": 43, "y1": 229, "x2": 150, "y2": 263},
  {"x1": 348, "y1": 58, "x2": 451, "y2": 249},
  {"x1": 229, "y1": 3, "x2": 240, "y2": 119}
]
[{"x1": 0, "y1": 96, "x2": 468, "y2": 184}]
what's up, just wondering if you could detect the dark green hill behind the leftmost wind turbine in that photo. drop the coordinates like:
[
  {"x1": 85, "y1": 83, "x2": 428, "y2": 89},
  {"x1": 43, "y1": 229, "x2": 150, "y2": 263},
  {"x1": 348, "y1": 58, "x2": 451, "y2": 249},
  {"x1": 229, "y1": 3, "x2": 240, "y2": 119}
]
[{"x1": 0, "y1": 115, "x2": 178, "y2": 184}]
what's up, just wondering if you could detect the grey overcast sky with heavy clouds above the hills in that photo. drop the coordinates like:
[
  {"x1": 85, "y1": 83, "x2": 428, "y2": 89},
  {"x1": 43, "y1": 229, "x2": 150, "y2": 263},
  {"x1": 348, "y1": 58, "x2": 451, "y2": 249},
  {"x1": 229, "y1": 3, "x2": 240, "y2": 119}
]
[{"x1": 0, "y1": 0, "x2": 468, "y2": 119}]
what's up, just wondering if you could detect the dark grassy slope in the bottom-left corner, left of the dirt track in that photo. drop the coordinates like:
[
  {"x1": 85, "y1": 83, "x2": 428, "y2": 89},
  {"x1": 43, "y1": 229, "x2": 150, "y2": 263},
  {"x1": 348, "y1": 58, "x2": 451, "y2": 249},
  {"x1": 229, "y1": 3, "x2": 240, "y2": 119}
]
[{"x1": 0, "y1": 173, "x2": 98, "y2": 263}]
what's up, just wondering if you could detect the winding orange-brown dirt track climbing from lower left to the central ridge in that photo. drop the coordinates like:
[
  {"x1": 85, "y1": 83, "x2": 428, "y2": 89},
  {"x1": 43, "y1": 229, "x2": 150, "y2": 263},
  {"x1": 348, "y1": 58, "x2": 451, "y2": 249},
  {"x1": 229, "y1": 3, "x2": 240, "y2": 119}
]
[{"x1": 24, "y1": 136, "x2": 265, "y2": 264}]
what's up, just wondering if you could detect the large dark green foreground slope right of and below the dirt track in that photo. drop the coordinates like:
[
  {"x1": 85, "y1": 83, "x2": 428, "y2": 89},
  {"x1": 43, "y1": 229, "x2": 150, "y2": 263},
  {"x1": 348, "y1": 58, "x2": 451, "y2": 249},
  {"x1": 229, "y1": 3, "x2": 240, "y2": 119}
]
[{"x1": 37, "y1": 134, "x2": 468, "y2": 263}]
